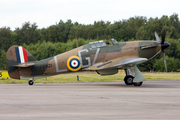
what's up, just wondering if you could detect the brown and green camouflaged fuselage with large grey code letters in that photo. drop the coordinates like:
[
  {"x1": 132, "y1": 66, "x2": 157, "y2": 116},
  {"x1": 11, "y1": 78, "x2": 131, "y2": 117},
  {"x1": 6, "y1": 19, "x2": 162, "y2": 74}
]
[{"x1": 20, "y1": 41, "x2": 161, "y2": 79}]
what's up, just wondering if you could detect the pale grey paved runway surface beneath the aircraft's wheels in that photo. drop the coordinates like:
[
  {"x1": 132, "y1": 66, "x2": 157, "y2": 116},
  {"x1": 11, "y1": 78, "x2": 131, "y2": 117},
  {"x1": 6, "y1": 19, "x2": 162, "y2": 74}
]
[{"x1": 0, "y1": 80, "x2": 180, "y2": 120}]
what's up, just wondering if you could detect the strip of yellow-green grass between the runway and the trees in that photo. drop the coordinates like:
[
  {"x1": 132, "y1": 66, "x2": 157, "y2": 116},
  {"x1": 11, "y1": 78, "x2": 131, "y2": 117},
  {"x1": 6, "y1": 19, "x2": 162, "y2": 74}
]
[{"x1": 0, "y1": 73, "x2": 180, "y2": 84}]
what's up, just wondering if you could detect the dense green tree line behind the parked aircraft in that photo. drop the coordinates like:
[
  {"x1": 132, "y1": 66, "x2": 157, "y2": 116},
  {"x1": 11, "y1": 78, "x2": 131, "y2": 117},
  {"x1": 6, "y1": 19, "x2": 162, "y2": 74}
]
[{"x1": 0, "y1": 14, "x2": 180, "y2": 71}]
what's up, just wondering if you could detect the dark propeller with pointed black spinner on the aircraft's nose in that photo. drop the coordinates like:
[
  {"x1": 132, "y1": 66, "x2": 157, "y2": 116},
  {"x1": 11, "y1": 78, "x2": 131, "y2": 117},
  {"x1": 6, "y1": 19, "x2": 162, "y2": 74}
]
[{"x1": 155, "y1": 30, "x2": 170, "y2": 72}]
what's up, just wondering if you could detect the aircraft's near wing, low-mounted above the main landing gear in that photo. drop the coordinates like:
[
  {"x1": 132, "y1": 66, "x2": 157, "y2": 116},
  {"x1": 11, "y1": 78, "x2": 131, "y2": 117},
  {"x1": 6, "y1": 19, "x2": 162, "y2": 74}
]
[{"x1": 88, "y1": 58, "x2": 148, "y2": 70}]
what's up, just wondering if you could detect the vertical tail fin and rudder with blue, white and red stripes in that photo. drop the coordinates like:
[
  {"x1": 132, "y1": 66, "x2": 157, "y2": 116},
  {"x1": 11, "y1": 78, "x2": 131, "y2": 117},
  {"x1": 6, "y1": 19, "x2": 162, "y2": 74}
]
[{"x1": 6, "y1": 45, "x2": 36, "y2": 79}]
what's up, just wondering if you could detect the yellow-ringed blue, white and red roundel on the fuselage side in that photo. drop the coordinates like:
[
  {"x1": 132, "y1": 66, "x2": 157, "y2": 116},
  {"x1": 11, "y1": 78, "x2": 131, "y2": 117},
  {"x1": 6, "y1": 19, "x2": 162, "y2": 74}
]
[{"x1": 67, "y1": 56, "x2": 81, "y2": 71}]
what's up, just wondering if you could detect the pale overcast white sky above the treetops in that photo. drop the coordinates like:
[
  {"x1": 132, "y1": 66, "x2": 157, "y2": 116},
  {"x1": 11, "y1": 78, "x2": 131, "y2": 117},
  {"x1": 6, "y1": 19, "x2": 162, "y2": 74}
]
[{"x1": 0, "y1": 0, "x2": 180, "y2": 30}]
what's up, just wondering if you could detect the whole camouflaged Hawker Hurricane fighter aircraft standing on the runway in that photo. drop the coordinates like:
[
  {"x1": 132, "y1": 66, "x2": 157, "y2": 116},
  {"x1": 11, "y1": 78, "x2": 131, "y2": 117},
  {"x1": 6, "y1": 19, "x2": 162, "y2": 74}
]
[{"x1": 6, "y1": 32, "x2": 169, "y2": 86}]
